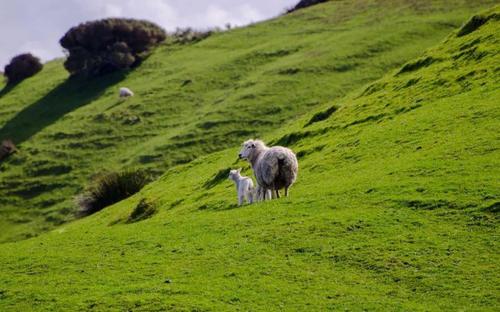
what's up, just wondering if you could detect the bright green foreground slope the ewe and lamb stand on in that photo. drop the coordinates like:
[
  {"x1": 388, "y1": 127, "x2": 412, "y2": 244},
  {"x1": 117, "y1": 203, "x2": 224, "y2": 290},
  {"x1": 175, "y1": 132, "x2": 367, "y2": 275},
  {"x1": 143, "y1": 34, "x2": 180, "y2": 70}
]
[{"x1": 0, "y1": 7, "x2": 500, "y2": 311}]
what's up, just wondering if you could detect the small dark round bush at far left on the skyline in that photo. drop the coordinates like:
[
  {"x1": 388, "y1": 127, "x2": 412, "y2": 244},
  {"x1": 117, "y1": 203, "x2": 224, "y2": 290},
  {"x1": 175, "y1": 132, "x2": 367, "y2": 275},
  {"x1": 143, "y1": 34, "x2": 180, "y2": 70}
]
[{"x1": 4, "y1": 53, "x2": 43, "y2": 84}]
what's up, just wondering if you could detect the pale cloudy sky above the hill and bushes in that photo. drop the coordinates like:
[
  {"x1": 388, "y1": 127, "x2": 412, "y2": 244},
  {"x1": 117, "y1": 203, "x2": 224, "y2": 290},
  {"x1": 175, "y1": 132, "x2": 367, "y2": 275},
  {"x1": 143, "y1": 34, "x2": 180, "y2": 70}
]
[{"x1": 0, "y1": 0, "x2": 298, "y2": 70}]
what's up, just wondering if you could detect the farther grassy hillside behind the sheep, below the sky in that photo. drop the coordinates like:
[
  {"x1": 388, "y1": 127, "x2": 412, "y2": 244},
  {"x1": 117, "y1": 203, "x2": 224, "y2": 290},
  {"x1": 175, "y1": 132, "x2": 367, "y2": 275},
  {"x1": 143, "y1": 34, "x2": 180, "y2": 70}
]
[{"x1": 0, "y1": 0, "x2": 494, "y2": 241}]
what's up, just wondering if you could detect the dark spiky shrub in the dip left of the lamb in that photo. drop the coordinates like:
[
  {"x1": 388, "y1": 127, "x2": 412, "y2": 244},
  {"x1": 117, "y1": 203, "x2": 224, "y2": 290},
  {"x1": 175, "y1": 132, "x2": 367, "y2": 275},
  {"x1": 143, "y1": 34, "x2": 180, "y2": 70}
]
[{"x1": 76, "y1": 170, "x2": 151, "y2": 216}]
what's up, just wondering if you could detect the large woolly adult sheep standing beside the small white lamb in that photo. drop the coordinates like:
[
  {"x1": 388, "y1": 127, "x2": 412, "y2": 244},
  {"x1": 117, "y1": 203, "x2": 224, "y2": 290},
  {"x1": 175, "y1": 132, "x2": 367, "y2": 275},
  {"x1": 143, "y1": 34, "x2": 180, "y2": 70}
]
[{"x1": 239, "y1": 140, "x2": 299, "y2": 200}]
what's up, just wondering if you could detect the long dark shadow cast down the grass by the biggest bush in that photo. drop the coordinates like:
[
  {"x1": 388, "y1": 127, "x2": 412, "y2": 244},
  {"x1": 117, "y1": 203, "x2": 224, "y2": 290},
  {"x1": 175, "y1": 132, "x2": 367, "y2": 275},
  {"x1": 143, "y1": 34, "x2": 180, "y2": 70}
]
[{"x1": 0, "y1": 72, "x2": 125, "y2": 145}]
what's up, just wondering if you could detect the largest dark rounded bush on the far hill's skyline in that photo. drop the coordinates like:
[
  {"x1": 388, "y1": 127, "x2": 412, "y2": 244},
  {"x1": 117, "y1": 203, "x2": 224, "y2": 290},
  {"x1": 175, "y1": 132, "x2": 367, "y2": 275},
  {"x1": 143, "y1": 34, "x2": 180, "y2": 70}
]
[{"x1": 60, "y1": 18, "x2": 167, "y2": 76}]
